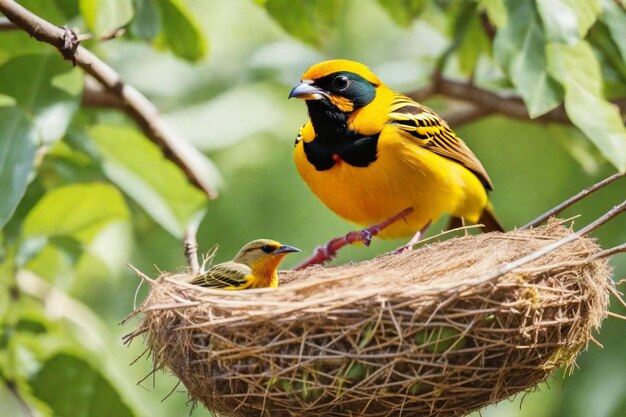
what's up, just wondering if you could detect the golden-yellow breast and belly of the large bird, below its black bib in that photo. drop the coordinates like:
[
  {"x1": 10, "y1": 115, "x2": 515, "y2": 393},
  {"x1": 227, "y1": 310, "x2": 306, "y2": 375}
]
[{"x1": 294, "y1": 125, "x2": 487, "y2": 238}]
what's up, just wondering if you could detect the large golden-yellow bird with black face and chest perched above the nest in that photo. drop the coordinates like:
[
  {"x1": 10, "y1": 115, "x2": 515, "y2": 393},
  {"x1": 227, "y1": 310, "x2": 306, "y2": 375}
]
[{"x1": 289, "y1": 59, "x2": 502, "y2": 238}]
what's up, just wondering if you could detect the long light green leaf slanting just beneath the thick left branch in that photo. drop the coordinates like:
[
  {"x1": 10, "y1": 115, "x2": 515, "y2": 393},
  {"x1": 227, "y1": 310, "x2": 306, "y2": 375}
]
[{"x1": 74, "y1": 125, "x2": 207, "y2": 237}]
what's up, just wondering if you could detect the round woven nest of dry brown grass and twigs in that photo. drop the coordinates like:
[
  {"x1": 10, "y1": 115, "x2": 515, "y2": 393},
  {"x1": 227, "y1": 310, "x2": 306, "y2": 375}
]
[{"x1": 129, "y1": 221, "x2": 612, "y2": 417}]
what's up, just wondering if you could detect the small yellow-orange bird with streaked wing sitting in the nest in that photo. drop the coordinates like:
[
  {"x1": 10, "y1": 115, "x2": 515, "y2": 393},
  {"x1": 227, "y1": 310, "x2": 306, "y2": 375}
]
[{"x1": 189, "y1": 239, "x2": 300, "y2": 290}]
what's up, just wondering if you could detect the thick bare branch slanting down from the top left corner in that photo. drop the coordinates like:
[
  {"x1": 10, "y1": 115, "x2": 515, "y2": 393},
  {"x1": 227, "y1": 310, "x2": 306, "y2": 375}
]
[{"x1": 0, "y1": 0, "x2": 217, "y2": 198}]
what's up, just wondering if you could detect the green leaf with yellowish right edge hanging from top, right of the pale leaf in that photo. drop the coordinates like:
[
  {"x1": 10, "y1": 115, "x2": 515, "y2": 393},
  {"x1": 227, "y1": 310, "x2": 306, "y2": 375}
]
[{"x1": 159, "y1": 0, "x2": 208, "y2": 61}]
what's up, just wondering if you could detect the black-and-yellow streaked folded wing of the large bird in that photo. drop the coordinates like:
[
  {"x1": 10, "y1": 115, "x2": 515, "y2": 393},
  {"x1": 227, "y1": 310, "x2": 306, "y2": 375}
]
[{"x1": 389, "y1": 94, "x2": 493, "y2": 190}]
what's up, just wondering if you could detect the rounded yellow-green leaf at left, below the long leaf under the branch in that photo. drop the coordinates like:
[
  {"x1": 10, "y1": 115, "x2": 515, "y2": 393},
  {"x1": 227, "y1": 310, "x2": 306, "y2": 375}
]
[{"x1": 23, "y1": 183, "x2": 128, "y2": 244}]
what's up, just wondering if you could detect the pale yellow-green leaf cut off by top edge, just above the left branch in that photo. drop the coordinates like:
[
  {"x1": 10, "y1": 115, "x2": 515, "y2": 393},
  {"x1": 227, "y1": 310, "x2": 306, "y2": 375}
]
[{"x1": 79, "y1": 0, "x2": 133, "y2": 37}]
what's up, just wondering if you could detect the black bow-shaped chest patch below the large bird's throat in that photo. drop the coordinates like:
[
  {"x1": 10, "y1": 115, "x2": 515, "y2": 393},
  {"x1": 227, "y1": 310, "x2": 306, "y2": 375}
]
[{"x1": 304, "y1": 134, "x2": 378, "y2": 171}]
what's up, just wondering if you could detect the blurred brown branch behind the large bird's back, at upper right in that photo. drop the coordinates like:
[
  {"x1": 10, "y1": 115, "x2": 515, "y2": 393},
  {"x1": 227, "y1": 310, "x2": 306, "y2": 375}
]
[{"x1": 407, "y1": 75, "x2": 626, "y2": 124}]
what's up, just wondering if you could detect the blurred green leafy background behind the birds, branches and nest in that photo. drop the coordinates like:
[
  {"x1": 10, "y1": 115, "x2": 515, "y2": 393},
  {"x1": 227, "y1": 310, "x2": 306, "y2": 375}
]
[{"x1": 0, "y1": 0, "x2": 626, "y2": 417}]
